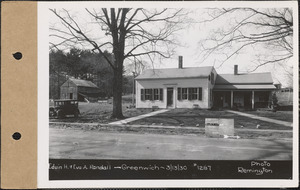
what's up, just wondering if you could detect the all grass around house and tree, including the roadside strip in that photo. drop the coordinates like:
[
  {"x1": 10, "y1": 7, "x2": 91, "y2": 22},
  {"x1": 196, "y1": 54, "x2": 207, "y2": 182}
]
[{"x1": 50, "y1": 101, "x2": 293, "y2": 139}]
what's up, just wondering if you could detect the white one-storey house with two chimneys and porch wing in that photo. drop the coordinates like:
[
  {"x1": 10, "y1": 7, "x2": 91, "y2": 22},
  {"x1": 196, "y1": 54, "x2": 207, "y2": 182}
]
[{"x1": 135, "y1": 56, "x2": 275, "y2": 109}]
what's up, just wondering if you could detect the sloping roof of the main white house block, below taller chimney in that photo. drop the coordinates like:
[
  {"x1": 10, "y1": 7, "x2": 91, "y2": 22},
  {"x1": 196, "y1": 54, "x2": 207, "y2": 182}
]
[{"x1": 135, "y1": 66, "x2": 213, "y2": 80}]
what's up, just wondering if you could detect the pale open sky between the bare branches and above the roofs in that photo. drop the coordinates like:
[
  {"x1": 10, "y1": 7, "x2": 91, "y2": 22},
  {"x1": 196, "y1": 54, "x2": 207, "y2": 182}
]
[{"x1": 49, "y1": 1, "x2": 298, "y2": 86}]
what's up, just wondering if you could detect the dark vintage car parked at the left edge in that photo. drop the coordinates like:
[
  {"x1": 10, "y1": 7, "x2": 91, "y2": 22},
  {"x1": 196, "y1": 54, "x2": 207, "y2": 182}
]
[{"x1": 49, "y1": 100, "x2": 80, "y2": 118}]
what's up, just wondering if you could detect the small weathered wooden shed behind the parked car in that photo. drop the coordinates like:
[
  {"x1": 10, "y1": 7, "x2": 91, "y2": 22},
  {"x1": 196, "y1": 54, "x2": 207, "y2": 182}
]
[{"x1": 60, "y1": 78, "x2": 103, "y2": 101}]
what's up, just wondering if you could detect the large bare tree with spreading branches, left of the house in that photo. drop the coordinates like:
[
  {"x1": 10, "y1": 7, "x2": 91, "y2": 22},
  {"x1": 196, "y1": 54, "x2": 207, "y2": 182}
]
[{"x1": 50, "y1": 8, "x2": 186, "y2": 118}]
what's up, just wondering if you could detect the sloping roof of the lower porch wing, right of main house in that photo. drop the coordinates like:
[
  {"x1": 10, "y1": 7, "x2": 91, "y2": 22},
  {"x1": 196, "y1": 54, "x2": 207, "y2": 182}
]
[{"x1": 216, "y1": 73, "x2": 273, "y2": 85}]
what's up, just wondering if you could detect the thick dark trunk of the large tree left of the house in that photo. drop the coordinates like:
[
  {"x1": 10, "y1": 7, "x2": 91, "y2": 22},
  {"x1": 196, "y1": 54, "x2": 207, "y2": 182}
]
[{"x1": 112, "y1": 68, "x2": 124, "y2": 119}]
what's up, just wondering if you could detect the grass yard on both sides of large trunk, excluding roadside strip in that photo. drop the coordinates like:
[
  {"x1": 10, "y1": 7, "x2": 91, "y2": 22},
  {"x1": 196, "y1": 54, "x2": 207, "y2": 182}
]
[{"x1": 50, "y1": 95, "x2": 293, "y2": 130}]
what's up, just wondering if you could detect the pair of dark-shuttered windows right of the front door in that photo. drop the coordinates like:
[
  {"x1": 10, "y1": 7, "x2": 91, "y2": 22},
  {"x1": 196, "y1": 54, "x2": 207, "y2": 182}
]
[{"x1": 177, "y1": 88, "x2": 202, "y2": 100}]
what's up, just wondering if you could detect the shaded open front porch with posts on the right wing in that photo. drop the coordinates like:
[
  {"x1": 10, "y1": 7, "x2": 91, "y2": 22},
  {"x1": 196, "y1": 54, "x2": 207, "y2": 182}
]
[{"x1": 213, "y1": 90, "x2": 271, "y2": 110}]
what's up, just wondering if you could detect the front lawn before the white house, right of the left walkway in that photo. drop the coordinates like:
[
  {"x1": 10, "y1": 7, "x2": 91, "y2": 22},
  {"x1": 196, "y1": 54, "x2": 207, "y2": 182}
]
[{"x1": 129, "y1": 109, "x2": 292, "y2": 130}]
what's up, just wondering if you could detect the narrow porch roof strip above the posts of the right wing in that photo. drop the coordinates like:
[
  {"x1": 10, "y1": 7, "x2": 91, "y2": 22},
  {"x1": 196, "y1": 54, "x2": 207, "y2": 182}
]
[{"x1": 213, "y1": 84, "x2": 276, "y2": 90}]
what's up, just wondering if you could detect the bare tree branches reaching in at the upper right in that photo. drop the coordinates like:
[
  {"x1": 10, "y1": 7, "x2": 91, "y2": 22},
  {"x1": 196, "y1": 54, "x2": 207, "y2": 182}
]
[{"x1": 199, "y1": 8, "x2": 293, "y2": 71}]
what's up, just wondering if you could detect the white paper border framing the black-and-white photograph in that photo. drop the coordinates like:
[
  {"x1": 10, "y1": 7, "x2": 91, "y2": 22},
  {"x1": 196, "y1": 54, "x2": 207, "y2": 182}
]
[{"x1": 37, "y1": 1, "x2": 299, "y2": 188}]
